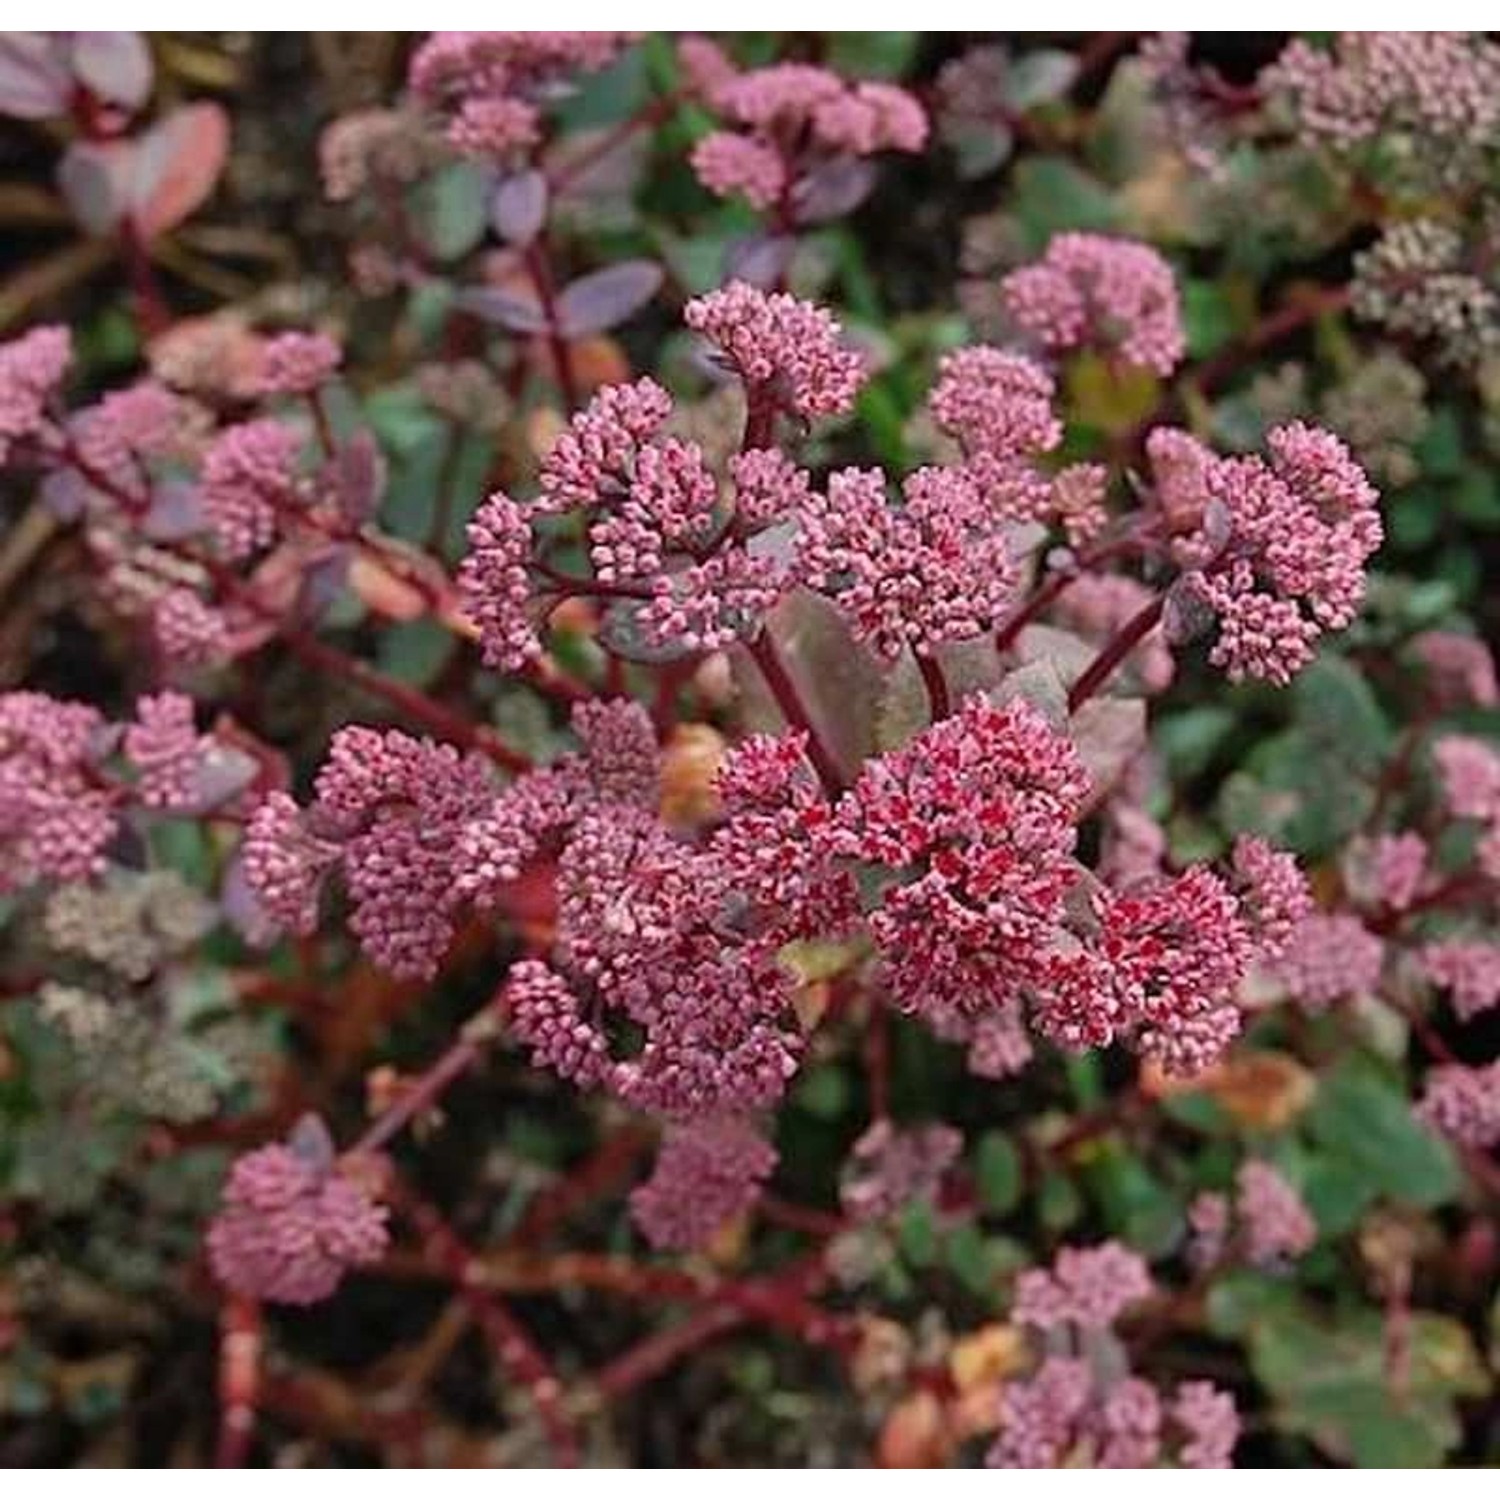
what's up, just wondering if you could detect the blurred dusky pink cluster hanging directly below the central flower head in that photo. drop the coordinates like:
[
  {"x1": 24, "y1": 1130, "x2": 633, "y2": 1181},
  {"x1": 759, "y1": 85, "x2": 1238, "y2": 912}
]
[{"x1": 630, "y1": 1116, "x2": 777, "y2": 1250}]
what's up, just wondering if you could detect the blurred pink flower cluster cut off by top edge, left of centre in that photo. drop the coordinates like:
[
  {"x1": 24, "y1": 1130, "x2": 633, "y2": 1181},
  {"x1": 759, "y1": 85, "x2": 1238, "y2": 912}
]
[{"x1": 408, "y1": 32, "x2": 635, "y2": 158}]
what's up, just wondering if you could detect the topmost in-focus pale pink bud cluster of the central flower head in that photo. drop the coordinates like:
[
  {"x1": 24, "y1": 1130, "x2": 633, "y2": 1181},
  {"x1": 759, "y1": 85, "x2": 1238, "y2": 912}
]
[{"x1": 683, "y1": 281, "x2": 866, "y2": 419}]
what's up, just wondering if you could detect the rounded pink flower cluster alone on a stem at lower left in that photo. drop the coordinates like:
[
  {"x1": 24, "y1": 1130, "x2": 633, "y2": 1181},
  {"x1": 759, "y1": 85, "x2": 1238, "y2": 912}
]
[{"x1": 209, "y1": 1121, "x2": 389, "y2": 1305}]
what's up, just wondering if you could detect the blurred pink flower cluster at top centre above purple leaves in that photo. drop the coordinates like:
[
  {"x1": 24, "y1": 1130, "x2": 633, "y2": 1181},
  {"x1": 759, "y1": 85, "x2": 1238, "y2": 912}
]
[{"x1": 680, "y1": 38, "x2": 927, "y2": 210}]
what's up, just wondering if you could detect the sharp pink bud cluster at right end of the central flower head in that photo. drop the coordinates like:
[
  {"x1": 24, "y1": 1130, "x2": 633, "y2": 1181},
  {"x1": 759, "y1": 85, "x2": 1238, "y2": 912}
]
[{"x1": 1170, "y1": 422, "x2": 1382, "y2": 686}]
